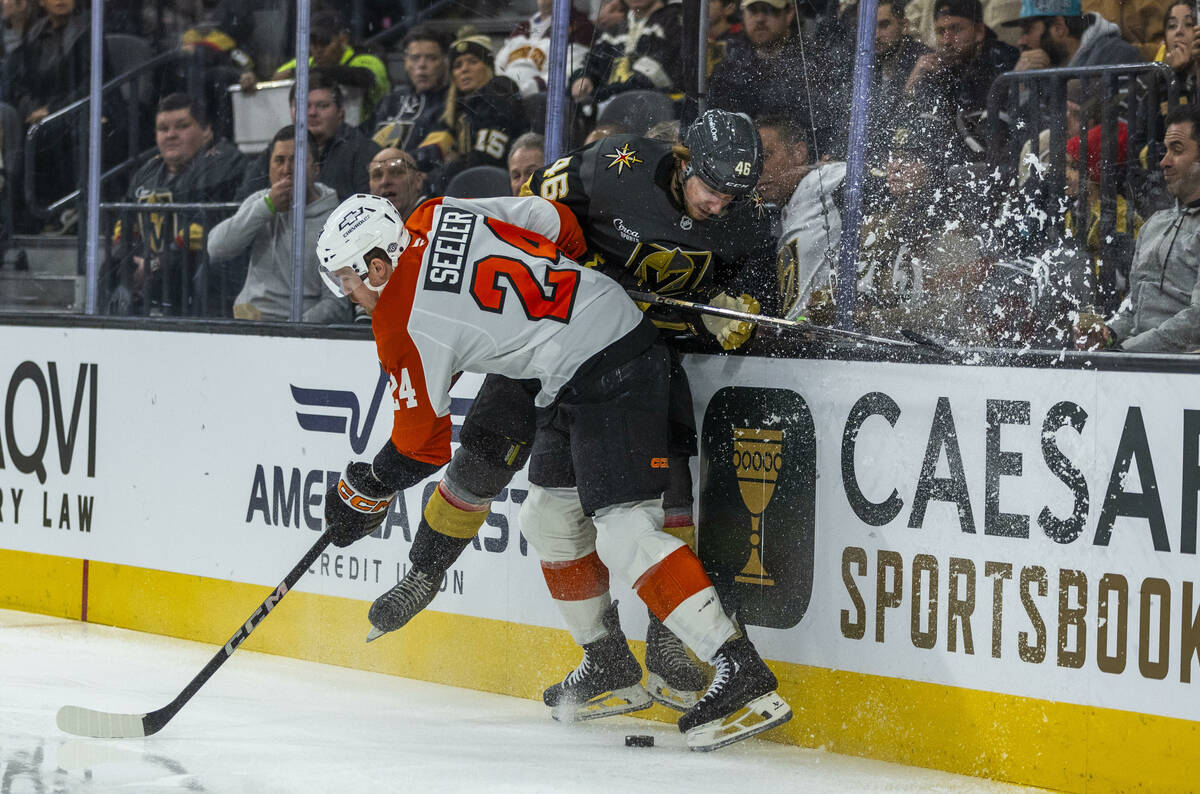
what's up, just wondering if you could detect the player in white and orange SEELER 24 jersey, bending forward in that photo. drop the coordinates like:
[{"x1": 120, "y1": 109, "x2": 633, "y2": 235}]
[{"x1": 318, "y1": 194, "x2": 792, "y2": 750}]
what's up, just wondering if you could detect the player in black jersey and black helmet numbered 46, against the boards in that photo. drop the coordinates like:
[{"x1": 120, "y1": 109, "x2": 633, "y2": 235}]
[{"x1": 526, "y1": 110, "x2": 775, "y2": 709}]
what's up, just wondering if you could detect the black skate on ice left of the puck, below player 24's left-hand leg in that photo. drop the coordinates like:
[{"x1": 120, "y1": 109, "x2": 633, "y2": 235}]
[{"x1": 541, "y1": 602, "x2": 653, "y2": 722}]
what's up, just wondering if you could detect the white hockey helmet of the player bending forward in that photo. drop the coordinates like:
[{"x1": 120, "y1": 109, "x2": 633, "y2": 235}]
[{"x1": 317, "y1": 193, "x2": 410, "y2": 297}]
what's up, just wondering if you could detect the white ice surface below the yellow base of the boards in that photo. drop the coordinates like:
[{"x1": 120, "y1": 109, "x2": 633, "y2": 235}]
[{"x1": 0, "y1": 610, "x2": 1041, "y2": 794}]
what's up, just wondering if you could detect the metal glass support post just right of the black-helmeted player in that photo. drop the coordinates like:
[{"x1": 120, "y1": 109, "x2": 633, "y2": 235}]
[{"x1": 836, "y1": 0, "x2": 877, "y2": 329}]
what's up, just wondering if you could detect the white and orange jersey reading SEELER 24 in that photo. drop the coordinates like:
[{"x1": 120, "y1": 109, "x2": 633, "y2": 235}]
[{"x1": 372, "y1": 197, "x2": 643, "y2": 464}]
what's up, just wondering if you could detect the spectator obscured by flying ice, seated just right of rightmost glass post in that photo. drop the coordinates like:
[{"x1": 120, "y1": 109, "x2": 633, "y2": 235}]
[{"x1": 857, "y1": 119, "x2": 988, "y2": 344}]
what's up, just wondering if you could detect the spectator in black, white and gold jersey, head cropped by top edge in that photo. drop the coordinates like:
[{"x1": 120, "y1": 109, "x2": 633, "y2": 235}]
[{"x1": 571, "y1": 0, "x2": 684, "y2": 102}]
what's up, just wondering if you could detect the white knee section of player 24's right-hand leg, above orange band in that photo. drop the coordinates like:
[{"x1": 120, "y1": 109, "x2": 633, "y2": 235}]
[{"x1": 592, "y1": 499, "x2": 684, "y2": 584}]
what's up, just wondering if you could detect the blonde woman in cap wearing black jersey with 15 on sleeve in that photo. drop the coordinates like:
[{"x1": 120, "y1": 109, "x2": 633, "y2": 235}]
[{"x1": 416, "y1": 29, "x2": 529, "y2": 194}]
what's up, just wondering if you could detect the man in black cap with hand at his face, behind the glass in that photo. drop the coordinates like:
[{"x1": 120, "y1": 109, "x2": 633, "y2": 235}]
[{"x1": 900, "y1": 0, "x2": 1002, "y2": 167}]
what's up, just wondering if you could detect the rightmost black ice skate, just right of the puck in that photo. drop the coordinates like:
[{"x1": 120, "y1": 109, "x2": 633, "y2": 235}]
[{"x1": 679, "y1": 634, "x2": 792, "y2": 751}]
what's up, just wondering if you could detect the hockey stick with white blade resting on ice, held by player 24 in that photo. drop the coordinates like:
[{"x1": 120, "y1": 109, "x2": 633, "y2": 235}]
[{"x1": 56, "y1": 534, "x2": 330, "y2": 739}]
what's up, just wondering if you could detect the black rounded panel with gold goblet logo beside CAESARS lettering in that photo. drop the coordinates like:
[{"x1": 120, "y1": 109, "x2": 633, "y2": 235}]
[{"x1": 700, "y1": 386, "x2": 816, "y2": 628}]
